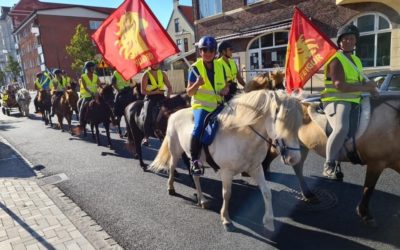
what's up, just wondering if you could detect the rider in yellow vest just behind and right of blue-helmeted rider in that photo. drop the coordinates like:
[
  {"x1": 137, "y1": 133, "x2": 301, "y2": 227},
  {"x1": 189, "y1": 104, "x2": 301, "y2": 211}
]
[{"x1": 218, "y1": 41, "x2": 246, "y2": 101}]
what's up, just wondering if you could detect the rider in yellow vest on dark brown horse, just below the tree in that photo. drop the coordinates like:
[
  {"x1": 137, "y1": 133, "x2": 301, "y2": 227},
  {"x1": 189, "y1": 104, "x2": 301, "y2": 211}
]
[{"x1": 79, "y1": 61, "x2": 100, "y2": 127}]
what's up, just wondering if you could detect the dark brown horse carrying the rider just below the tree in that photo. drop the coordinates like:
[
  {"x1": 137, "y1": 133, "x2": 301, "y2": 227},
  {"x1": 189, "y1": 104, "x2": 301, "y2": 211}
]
[{"x1": 80, "y1": 85, "x2": 115, "y2": 148}]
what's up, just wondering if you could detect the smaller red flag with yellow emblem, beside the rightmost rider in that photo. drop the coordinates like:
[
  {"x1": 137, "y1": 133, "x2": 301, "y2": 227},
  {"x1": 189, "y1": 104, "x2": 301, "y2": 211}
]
[{"x1": 286, "y1": 8, "x2": 337, "y2": 93}]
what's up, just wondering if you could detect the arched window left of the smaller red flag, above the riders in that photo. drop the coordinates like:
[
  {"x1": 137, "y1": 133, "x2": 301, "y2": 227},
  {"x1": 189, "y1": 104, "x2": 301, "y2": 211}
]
[{"x1": 249, "y1": 31, "x2": 288, "y2": 70}]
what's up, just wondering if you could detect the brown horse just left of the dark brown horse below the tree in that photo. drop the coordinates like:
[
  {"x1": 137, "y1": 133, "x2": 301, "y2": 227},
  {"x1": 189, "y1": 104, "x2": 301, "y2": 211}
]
[{"x1": 55, "y1": 89, "x2": 79, "y2": 133}]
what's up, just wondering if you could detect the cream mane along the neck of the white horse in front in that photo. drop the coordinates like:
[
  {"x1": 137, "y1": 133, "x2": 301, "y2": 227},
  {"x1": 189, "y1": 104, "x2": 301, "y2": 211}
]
[{"x1": 219, "y1": 90, "x2": 271, "y2": 129}]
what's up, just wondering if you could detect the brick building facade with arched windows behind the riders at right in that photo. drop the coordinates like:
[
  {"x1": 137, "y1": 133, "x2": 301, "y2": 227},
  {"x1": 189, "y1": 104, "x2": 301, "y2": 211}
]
[{"x1": 193, "y1": 0, "x2": 400, "y2": 85}]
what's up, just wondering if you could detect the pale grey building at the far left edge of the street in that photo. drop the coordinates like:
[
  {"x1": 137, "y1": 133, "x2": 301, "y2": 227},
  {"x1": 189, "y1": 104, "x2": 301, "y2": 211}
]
[{"x1": 0, "y1": 7, "x2": 17, "y2": 85}]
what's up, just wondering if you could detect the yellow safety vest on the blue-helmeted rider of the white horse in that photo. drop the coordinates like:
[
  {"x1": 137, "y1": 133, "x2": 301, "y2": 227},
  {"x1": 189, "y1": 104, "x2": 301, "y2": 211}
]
[{"x1": 191, "y1": 59, "x2": 225, "y2": 112}]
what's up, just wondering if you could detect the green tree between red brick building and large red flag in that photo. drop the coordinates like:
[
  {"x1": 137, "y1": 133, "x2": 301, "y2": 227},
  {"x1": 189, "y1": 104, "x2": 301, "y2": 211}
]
[{"x1": 65, "y1": 24, "x2": 96, "y2": 73}]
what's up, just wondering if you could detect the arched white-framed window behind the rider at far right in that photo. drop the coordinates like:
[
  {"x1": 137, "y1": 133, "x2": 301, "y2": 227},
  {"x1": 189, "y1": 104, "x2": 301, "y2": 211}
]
[{"x1": 352, "y1": 13, "x2": 392, "y2": 67}]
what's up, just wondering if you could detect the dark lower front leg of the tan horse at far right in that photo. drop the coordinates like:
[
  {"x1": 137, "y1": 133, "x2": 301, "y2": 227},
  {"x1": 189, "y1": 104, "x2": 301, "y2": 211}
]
[{"x1": 356, "y1": 162, "x2": 385, "y2": 222}]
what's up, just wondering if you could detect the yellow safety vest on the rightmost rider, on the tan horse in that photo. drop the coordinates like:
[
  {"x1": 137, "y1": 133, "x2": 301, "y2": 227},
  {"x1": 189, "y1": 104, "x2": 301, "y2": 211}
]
[{"x1": 321, "y1": 52, "x2": 364, "y2": 103}]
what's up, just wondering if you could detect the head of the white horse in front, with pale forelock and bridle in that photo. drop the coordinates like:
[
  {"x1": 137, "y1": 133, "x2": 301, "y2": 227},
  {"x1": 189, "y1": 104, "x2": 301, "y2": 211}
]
[{"x1": 266, "y1": 91, "x2": 303, "y2": 166}]
